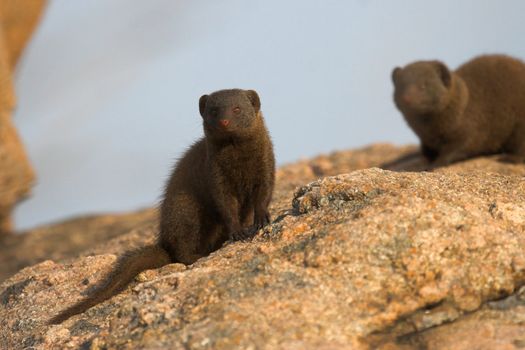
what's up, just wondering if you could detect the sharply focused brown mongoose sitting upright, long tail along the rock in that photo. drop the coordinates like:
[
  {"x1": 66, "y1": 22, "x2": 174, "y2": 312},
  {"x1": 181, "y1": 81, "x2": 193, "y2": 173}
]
[{"x1": 49, "y1": 89, "x2": 275, "y2": 324}]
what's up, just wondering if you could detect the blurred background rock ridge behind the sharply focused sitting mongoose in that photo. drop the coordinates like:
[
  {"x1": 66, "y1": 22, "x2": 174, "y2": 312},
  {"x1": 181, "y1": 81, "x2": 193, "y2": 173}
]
[{"x1": 0, "y1": 144, "x2": 414, "y2": 282}]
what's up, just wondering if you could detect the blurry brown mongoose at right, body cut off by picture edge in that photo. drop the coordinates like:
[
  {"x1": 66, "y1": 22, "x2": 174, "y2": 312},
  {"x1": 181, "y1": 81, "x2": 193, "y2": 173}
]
[{"x1": 392, "y1": 55, "x2": 525, "y2": 167}]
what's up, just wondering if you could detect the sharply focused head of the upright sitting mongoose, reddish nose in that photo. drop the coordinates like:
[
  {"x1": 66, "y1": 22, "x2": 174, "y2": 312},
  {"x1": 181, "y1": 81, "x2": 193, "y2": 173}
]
[{"x1": 199, "y1": 89, "x2": 261, "y2": 137}]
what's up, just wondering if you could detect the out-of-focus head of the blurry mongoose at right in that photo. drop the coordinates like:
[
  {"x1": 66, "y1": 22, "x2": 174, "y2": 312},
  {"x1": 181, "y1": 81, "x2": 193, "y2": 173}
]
[{"x1": 392, "y1": 61, "x2": 452, "y2": 116}]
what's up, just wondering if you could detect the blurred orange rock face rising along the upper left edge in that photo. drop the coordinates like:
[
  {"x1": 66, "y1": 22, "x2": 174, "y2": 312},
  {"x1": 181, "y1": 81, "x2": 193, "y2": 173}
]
[{"x1": 0, "y1": 0, "x2": 45, "y2": 235}]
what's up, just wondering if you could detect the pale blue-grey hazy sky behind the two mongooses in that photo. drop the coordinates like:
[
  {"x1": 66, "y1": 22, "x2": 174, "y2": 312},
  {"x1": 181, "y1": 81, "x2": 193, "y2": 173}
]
[{"x1": 14, "y1": 0, "x2": 525, "y2": 229}]
